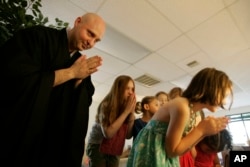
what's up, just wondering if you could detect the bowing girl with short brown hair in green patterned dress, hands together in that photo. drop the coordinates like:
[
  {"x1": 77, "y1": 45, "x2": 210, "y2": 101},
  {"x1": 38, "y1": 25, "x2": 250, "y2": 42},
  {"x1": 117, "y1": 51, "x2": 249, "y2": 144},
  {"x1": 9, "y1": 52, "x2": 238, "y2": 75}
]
[{"x1": 127, "y1": 68, "x2": 232, "y2": 167}]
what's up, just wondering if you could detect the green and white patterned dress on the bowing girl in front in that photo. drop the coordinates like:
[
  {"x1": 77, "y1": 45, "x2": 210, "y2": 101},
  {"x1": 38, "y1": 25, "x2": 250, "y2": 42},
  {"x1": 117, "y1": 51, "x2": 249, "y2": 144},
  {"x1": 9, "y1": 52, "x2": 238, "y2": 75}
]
[{"x1": 127, "y1": 120, "x2": 180, "y2": 167}]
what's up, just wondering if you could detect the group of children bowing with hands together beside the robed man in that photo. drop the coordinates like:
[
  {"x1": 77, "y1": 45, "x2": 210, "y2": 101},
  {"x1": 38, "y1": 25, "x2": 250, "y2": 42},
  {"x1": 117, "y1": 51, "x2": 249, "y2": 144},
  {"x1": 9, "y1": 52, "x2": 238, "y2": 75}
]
[{"x1": 86, "y1": 68, "x2": 233, "y2": 167}]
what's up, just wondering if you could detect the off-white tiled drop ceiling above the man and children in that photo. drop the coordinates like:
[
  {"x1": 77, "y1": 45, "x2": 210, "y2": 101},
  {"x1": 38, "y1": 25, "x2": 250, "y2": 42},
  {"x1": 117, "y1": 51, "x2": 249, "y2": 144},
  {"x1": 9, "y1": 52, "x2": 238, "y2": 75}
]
[{"x1": 41, "y1": 0, "x2": 250, "y2": 122}]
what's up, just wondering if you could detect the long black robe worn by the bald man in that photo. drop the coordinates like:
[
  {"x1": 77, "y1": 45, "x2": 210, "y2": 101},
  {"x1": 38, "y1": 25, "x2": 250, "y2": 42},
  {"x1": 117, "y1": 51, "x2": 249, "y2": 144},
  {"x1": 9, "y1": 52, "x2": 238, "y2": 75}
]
[{"x1": 0, "y1": 26, "x2": 94, "y2": 167}]
